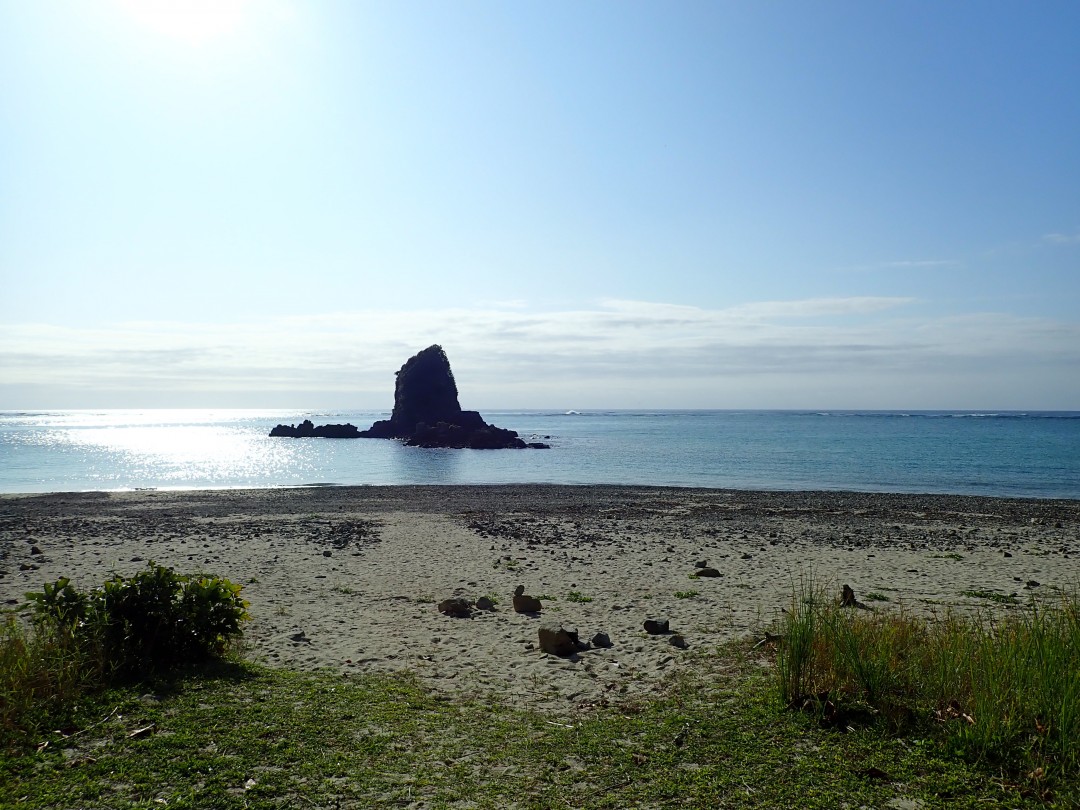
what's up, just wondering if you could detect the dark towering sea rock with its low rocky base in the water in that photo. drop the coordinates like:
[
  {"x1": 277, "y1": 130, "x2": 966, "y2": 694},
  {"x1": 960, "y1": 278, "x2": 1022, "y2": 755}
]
[{"x1": 264, "y1": 346, "x2": 549, "y2": 450}]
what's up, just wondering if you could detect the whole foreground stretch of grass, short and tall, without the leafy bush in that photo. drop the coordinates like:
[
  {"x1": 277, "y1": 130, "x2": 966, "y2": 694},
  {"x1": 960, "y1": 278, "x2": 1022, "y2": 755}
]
[{"x1": 8, "y1": 570, "x2": 1080, "y2": 810}]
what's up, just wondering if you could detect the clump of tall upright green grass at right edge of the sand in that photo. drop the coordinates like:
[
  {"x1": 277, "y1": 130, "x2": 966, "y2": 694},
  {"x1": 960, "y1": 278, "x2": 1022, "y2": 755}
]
[{"x1": 777, "y1": 581, "x2": 1080, "y2": 794}]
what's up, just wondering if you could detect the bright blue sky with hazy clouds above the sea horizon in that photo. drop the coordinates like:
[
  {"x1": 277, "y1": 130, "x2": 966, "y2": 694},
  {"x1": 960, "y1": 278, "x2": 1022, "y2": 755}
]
[{"x1": 0, "y1": 0, "x2": 1080, "y2": 409}]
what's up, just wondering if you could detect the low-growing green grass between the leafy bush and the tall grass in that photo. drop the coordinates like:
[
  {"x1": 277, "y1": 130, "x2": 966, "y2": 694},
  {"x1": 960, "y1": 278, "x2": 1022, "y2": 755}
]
[{"x1": 0, "y1": 647, "x2": 1080, "y2": 810}]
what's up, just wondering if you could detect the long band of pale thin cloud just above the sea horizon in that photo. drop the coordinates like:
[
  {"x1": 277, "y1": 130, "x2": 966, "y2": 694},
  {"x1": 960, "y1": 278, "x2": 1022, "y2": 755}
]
[{"x1": 0, "y1": 297, "x2": 1080, "y2": 408}]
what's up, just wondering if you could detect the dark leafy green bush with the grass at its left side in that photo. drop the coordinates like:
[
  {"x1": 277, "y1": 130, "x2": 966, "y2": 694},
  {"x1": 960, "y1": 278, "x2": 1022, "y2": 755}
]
[{"x1": 0, "y1": 563, "x2": 248, "y2": 746}]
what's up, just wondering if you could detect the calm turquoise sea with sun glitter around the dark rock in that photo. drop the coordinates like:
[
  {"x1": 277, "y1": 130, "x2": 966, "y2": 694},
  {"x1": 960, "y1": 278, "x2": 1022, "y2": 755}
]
[{"x1": 0, "y1": 410, "x2": 1080, "y2": 498}]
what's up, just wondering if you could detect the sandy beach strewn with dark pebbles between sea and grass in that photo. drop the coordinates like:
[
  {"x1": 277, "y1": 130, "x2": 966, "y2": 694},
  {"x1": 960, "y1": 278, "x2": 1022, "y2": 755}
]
[{"x1": 0, "y1": 485, "x2": 1080, "y2": 712}]
